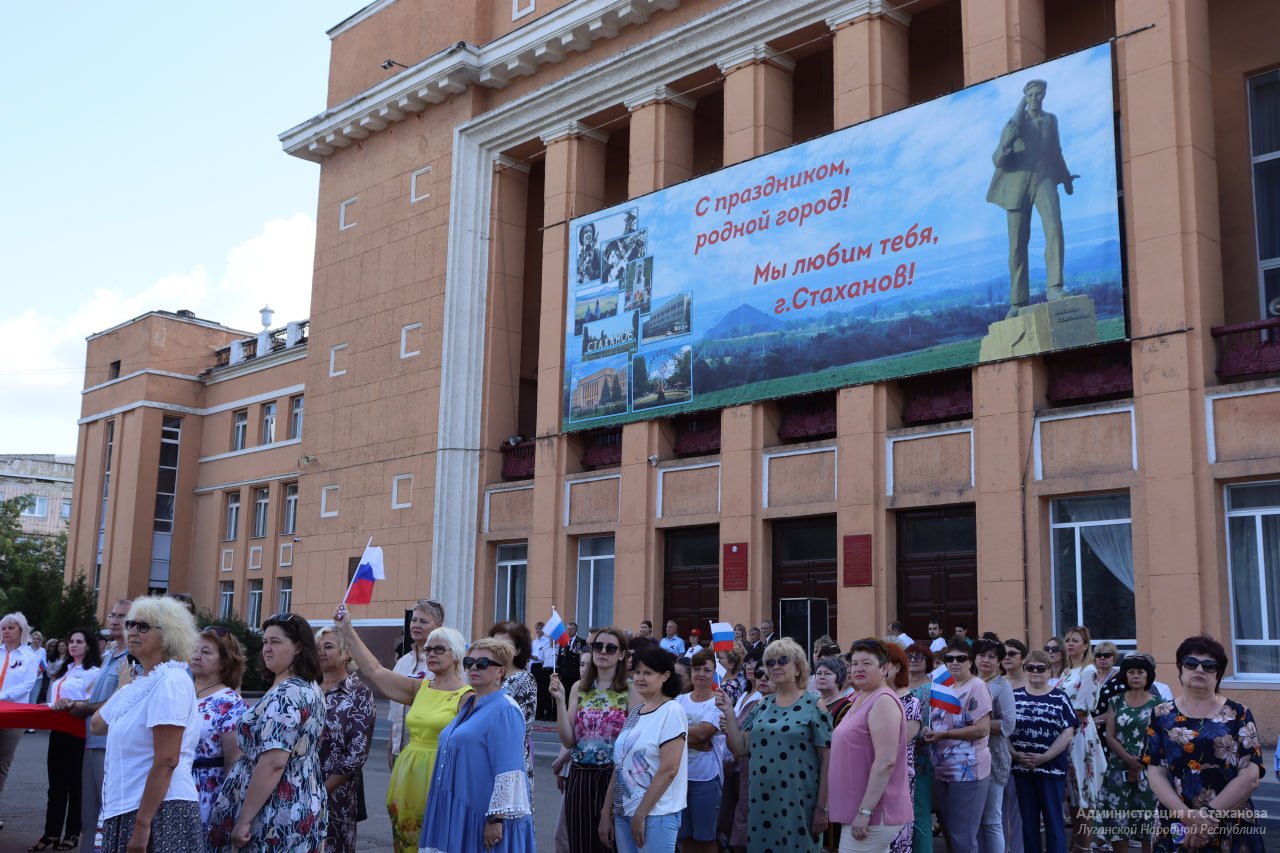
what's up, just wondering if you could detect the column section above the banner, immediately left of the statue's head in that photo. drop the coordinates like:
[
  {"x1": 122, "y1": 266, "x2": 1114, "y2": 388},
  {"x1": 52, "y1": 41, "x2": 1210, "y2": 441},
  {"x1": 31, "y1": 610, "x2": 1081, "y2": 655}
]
[{"x1": 960, "y1": 0, "x2": 1044, "y2": 86}]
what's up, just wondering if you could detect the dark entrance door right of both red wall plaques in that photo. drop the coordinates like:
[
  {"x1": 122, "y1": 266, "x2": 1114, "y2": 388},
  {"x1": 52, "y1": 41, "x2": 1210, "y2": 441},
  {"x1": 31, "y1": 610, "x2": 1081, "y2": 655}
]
[{"x1": 897, "y1": 506, "x2": 978, "y2": 640}]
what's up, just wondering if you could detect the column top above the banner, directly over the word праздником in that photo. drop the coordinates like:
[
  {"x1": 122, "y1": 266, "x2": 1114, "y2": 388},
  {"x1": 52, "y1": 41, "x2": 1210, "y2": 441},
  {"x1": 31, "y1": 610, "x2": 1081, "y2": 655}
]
[{"x1": 717, "y1": 45, "x2": 796, "y2": 165}]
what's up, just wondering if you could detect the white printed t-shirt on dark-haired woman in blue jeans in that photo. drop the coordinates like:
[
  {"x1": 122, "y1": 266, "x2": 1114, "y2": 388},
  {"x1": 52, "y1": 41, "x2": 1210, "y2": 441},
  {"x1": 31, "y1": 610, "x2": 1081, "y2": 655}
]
[{"x1": 613, "y1": 701, "x2": 689, "y2": 817}]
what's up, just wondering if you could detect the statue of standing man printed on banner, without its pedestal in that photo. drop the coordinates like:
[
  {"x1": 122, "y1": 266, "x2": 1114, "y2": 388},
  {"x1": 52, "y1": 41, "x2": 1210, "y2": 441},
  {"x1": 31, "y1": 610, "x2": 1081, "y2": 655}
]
[{"x1": 987, "y1": 79, "x2": 1080, "y2": 318}]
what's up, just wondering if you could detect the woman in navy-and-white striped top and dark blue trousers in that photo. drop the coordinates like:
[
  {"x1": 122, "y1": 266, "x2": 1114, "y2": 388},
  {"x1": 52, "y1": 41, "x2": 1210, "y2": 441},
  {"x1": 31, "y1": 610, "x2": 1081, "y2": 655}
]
[{"x1": 1009, "y1": 649, "x2": 1076, "y2": 853}]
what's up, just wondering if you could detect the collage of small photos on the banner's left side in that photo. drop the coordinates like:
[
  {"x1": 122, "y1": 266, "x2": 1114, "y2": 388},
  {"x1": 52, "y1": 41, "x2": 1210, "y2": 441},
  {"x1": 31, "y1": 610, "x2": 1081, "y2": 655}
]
[{"x1": 566, "y1": 207, "x2": 694, "y2": 424}]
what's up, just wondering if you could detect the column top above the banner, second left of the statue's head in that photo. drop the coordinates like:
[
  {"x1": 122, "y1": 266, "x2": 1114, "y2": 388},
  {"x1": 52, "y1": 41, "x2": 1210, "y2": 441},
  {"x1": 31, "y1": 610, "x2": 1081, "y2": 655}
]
[{"x1": 827, "y1": 0, "x2": 911, "y2": 129}]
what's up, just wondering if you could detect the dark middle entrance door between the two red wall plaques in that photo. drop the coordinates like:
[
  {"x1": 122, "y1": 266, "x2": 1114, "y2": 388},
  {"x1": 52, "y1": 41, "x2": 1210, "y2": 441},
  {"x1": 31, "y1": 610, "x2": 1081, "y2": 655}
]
[{"x1": 772, "y1": 515, "x2": 836, "y2": 640}]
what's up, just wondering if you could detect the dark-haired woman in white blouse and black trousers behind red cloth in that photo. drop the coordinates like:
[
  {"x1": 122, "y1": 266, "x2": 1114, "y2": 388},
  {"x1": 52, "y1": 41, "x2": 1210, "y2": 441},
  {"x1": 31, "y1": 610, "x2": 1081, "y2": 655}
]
[{"x1": 28, "y1": 628, "x2": 102, "y2": 850}]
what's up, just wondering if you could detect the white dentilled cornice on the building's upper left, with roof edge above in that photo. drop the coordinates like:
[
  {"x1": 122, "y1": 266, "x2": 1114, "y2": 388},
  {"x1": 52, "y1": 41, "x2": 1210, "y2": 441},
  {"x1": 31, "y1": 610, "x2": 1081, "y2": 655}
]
[{"x1": 279, "y1": 0, "x2": 680, "y2": 161}]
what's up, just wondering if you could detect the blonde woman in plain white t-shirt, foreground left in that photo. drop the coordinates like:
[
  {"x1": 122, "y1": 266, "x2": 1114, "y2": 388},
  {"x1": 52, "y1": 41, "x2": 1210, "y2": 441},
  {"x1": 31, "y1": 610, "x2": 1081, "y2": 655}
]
[{"x1": 90, "y1": 596, "x2": 205, "y2": 853}]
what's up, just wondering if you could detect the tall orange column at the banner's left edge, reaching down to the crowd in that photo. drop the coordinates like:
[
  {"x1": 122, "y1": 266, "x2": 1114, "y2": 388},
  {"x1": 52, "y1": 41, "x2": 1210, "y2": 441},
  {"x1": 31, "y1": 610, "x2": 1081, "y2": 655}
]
[{"x1": 527, "y1": 123, "x2": 605, "y2": 621}]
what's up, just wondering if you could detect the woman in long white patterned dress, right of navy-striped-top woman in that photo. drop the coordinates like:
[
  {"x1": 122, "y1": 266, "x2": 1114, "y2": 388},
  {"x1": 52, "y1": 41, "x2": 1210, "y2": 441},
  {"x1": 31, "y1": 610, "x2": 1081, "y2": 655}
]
[{"x1": 1057, "y1": 625, "x2": 1107, "y2": 853}]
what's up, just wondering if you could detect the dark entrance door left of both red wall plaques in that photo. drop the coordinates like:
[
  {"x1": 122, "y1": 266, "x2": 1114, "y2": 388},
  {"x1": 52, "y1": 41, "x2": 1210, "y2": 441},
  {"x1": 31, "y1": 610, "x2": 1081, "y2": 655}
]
[{"x1": 665, "y1": 525, "x2": 719, "y2": 638}]
